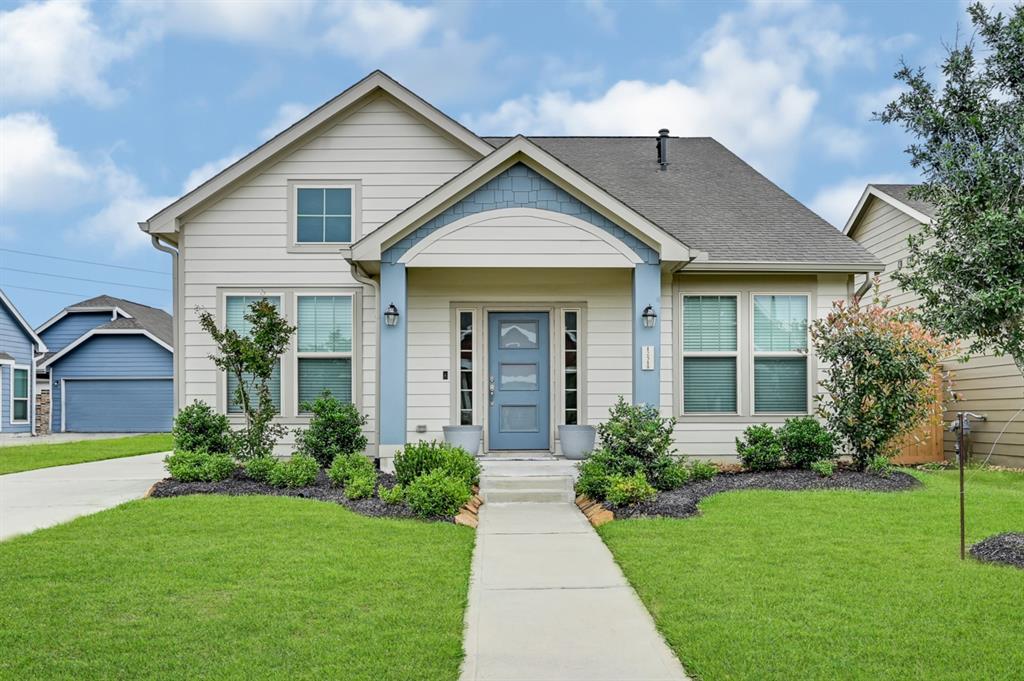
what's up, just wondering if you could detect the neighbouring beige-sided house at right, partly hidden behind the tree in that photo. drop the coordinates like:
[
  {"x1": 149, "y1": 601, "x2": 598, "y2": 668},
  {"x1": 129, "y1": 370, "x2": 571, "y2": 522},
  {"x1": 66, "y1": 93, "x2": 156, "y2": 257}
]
[{"x1": 844, "y1": 184, "x2": 1024, "y2": 467}]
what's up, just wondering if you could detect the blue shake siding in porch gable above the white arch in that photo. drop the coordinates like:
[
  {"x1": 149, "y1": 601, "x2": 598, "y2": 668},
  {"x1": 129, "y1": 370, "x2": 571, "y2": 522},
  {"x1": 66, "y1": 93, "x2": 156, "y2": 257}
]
[{"x1": 381, "y1": 163, "x2": 659, "y2": 264}]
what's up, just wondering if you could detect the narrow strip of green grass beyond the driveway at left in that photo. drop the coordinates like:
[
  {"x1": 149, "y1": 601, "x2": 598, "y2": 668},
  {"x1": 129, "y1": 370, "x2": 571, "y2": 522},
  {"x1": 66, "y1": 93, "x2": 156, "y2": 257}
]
[{"x1": 0, "y1": 433, "x2": 174, "y2": 475}]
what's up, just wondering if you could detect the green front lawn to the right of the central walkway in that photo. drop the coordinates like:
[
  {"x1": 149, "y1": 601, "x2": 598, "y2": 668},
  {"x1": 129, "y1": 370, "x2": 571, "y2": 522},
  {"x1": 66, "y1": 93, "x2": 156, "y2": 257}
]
[{"x1": 600, "y1": 471, "x2": 1024, "y2": 680}]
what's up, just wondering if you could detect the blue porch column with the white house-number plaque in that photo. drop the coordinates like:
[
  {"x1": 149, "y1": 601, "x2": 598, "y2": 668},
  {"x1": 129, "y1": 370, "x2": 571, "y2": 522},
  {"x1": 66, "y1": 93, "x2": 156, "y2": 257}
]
[{"x1": 633, "y1": 262, "x2": 662, "y2": 407}]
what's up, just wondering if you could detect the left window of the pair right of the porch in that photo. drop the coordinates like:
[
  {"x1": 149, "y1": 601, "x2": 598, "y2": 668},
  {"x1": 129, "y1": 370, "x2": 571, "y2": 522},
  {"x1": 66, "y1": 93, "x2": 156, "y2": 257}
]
[{"x1": 682, "y1": 295, "x2": 739, "y2": 414}]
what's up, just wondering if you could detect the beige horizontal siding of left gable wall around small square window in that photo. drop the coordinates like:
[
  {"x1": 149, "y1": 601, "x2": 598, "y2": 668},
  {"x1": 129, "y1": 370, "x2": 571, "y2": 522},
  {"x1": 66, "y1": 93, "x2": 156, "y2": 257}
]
[{"x1": 179, "y1": 91, "x2": 475, "y2": 453}]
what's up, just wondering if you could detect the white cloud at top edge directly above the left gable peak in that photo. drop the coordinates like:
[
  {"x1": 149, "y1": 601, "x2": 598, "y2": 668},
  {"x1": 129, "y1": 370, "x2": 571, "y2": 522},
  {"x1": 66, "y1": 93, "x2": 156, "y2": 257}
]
[{"x1": 324, "y1": 0, "x2": 436, "y2": 60}]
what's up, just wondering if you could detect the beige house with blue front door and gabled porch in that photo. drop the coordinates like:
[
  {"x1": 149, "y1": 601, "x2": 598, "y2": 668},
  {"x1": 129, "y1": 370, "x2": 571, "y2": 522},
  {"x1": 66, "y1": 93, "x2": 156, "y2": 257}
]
[{"x1": 139, "y1": 72, "x2": 882, "y2": 468}]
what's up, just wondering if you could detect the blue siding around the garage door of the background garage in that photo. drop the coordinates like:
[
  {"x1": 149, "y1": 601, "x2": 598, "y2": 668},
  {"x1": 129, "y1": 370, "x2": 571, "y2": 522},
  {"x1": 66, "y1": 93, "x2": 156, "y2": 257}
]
[{"x1": 50, "y1": 334, "x2": 174, "y2": 432}]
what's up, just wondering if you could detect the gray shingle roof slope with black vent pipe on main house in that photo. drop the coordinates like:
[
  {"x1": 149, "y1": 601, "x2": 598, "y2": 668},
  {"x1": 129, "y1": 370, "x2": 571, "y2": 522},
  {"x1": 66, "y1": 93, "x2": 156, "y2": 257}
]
[{"x1": 484, "y1": 136, "x2": 881, "y2": 265}]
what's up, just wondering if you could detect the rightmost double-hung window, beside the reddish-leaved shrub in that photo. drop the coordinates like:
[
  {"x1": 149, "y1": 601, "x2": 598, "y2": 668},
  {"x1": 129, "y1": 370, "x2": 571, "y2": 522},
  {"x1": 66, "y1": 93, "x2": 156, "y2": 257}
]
[{"x1": 754, "y1": 295, "x2": 809, "y2": 414}]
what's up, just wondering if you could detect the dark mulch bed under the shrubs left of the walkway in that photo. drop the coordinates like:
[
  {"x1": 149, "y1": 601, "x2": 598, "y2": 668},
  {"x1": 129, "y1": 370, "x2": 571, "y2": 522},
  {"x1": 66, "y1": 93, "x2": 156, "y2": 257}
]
[{"x1": 150, "y1": 468, "x2": 423, "y2": 522}]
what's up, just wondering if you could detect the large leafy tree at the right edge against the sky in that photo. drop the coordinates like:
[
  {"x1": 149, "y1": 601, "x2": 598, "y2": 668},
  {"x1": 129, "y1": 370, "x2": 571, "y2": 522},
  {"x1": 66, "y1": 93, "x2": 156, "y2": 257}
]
[{"x1": 878, "y1": 3, "x2": 1024, "y2": 372}]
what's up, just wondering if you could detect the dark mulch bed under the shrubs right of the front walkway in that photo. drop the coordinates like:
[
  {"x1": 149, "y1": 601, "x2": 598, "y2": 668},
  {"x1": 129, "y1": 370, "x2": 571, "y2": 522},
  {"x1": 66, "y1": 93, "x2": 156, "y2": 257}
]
[{"x1": 609, "y1": 468, "x2": 921, "y2": 518}]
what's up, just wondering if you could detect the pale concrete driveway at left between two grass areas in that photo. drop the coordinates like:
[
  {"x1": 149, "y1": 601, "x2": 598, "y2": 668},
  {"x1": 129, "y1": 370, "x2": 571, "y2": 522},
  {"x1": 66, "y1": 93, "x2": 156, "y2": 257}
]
[{"x1": 0, "y1": 452, "x2": 169, "y2": 540}]
